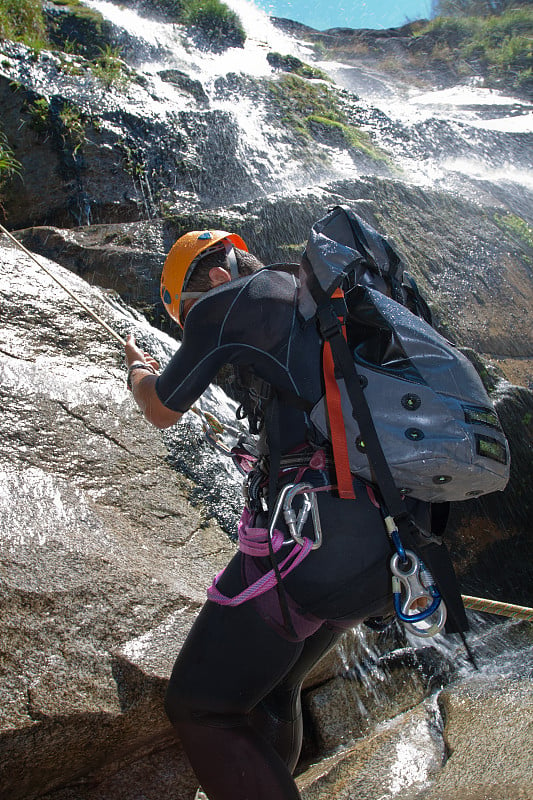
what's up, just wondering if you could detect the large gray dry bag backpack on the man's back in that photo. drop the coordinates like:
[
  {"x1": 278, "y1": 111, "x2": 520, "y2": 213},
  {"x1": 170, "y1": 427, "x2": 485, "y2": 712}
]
[{"x1": 299, "y1": 206, "x2": 510, "y2": 502}]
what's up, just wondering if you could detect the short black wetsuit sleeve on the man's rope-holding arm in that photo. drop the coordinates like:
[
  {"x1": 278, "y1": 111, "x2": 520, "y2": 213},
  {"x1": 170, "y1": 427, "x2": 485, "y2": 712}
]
[{"x1": 155, "y1": 291, "x2": 236, "y2": 413}]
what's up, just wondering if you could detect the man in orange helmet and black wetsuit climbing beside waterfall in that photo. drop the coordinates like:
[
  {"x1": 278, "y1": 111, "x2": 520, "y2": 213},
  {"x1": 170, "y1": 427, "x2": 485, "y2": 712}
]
[{"x1": 126, "y1": 231, "x2": 429, "y2": 800}]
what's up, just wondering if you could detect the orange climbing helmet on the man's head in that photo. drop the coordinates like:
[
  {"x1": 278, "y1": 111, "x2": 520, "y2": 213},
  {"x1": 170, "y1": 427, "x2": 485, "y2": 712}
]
[{"x1": 161, "y1": 231, "x2": 248, "y2": 327}]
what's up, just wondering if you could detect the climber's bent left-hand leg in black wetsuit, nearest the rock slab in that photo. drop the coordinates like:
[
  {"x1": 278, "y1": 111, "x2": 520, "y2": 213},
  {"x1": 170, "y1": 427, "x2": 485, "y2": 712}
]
[{"x1": 166, "y1": 556, "x2": 304, "y2": 800}]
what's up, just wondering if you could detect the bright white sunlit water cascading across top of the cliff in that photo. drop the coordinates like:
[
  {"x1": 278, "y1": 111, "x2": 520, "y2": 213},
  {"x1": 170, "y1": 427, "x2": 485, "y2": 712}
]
[{"x1": 80, "y1": 0, "x2": 533, "y2": 195}]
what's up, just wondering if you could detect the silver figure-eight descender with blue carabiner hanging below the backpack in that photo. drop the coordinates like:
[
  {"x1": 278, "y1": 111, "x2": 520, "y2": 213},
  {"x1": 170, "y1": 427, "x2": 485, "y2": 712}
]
[{"x1": 390, "y1": 550, "x2": 447, "y2": 638}]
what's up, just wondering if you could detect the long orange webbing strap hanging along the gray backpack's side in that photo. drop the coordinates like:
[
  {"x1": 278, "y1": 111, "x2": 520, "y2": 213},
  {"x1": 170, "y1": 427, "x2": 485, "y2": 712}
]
[{"x1": 323, "y1": 289, "x2": 355, "y2": 500}]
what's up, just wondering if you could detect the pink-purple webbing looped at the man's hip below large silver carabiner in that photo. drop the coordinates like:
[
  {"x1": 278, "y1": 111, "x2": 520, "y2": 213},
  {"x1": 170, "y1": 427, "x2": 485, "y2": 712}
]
[{"x1": 207, "y1": 508, "x2": 314, "y2": 606}]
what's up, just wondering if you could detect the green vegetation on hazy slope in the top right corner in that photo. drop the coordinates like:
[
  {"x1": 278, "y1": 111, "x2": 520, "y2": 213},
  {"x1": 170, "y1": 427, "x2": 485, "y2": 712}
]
[{"x1": 299, "y1": 0, "x2": 533, "y2": 99}]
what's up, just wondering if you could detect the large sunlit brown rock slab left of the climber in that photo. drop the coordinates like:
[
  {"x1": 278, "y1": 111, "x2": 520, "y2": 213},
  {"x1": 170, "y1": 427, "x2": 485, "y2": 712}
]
[{"x1": 0, "y1": 242, "x2": 232, "y2": 798}]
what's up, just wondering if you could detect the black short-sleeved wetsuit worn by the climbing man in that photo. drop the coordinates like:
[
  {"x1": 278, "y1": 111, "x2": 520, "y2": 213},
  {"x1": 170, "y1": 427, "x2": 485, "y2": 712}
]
[{"x1": 157, "y1": 269, "x2": 428, "y2": 800}]
